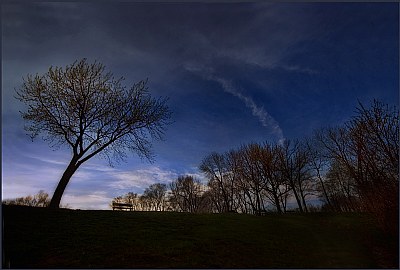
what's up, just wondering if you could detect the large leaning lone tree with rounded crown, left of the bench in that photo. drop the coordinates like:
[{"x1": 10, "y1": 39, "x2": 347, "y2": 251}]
[{"x1": 16, "y1": 59, "x2": 171, "y2": 208}]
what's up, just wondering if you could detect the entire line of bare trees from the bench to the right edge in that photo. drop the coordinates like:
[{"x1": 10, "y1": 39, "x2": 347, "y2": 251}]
[{"x1": 114, "y1": 100, "x2": 399, "y2": 234}]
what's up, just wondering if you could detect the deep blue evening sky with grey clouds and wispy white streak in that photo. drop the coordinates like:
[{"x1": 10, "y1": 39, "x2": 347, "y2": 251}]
[{"x1": 1, "y1": 2, "x2": 399, "y2": 209}]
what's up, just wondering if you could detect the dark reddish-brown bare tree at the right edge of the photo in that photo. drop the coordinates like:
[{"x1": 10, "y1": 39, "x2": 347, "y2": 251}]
[{"x1": 321, "y1": 100, "x2": 399, "y2": 233}]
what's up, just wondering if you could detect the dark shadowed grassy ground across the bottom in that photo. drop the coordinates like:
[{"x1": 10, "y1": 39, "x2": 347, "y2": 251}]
[{"x1": 3, "y1": 206, "x2": 398, "y2": 268}]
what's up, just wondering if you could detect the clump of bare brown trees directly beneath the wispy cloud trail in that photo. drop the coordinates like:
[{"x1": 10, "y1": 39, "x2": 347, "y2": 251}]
[{"x1": 200, "y1": 141, "x2": 315, "y2": 214}]
